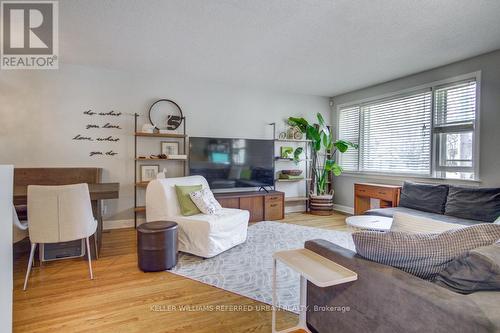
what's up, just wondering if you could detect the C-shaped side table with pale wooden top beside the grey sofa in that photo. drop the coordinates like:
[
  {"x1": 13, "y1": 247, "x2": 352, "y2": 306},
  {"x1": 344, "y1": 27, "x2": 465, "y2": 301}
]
[{"x1": 272, "y1": 249, "x2": 358, "y2": 333}]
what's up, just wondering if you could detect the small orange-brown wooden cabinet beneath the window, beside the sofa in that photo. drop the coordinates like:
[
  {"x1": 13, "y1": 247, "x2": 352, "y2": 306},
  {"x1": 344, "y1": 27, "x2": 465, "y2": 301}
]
[{"x1": 354, "y1": 183, "x2": 401, "y2": 215}]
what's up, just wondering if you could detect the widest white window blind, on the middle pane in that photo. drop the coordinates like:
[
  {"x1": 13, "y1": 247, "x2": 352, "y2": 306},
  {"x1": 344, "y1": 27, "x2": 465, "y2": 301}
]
[{"x1": 360, "y1": 90, "x2": 432, "y2": 174}]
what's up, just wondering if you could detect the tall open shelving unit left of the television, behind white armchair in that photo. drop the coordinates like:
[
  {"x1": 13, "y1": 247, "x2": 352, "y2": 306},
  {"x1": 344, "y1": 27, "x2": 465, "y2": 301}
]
[{"x1": 134, "y1": 113, "x2": 187, "y2": 228}]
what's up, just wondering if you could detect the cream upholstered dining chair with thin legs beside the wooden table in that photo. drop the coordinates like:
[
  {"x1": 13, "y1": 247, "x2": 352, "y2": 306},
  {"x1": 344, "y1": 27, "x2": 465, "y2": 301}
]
[{"x1": 24, "y1": 184, "x2": 97, "y2": 290}]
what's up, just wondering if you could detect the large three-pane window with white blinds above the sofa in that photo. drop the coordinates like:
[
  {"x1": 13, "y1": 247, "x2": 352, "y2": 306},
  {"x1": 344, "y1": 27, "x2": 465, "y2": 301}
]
[{"x1": 338, "y1": 78, "x2": 477, "y2": 179}]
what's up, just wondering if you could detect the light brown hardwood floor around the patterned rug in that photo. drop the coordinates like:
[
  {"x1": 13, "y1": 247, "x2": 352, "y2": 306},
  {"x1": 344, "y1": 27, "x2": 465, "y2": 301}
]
[{"x1": 14, "y1": 213, "x2": 346, "y2": 333}]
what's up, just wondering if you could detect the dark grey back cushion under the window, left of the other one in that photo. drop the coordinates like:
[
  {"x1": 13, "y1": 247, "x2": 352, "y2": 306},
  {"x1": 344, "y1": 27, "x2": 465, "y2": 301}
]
[{"x1": 399, "y1": 182, "x2": 448, "y2": 214}]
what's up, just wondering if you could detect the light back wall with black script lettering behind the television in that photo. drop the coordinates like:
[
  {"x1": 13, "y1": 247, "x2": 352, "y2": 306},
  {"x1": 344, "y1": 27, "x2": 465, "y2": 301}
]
[{"x1": 0, "y1": 64, "x2": 330, "y2": 220}]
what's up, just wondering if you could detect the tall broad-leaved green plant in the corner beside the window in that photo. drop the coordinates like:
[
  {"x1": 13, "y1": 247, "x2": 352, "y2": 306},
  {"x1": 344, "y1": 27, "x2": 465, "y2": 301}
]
[{"x1": 288, "y1": 113, "x2": 358, "y2": 196}]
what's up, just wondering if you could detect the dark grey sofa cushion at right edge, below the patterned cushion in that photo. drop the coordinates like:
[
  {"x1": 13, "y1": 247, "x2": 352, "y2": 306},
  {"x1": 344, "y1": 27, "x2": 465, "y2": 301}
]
[{"x1": 433, "y1": 242, "x2": 500, "y2": 294}]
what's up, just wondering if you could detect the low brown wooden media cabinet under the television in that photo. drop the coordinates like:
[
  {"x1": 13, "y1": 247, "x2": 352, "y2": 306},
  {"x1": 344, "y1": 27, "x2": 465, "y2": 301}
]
[{"x1": 214, "y1": 191, "x2": 285, "y2": 222}]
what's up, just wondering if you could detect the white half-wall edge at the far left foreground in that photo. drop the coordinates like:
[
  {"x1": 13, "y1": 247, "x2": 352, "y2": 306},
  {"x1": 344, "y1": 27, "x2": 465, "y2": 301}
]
[{"x1": 0, "y1": 165, "x2": 13, "y2": 332}]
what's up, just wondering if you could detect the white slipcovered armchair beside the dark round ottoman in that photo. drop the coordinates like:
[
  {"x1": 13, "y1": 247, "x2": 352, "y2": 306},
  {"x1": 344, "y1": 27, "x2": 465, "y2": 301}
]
[{"x1": 146, "y1": 176, "x2": 250, "y2": 258}]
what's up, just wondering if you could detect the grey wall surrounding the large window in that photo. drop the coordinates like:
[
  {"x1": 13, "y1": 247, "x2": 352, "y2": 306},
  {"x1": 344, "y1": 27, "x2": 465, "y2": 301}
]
[{"x1": 332, "y1": 50, "x2": 500, "y2": 209}]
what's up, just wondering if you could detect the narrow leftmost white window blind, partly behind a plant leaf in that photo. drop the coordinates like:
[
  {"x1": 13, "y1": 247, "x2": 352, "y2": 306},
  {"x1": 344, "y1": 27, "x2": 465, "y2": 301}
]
[{"x1": 338, "y1": 106, "x2": 359, "y2": 171}]
